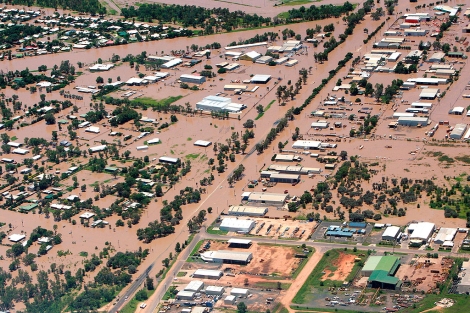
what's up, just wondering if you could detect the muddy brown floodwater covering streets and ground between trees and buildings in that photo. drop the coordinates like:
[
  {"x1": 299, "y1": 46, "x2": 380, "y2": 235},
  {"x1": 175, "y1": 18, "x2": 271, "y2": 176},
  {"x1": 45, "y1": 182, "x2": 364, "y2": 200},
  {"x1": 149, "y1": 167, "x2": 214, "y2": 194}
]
[{"x1": 0, "y1": 2, "x2": 469, "y2": 310}]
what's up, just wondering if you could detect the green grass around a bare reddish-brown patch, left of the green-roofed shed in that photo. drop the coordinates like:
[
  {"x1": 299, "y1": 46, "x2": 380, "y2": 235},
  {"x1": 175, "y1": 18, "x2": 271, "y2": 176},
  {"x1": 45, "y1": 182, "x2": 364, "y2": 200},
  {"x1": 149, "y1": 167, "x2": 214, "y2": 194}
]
[{"x1": 292, "y1": 249, "x2": 367, "y2": 304}]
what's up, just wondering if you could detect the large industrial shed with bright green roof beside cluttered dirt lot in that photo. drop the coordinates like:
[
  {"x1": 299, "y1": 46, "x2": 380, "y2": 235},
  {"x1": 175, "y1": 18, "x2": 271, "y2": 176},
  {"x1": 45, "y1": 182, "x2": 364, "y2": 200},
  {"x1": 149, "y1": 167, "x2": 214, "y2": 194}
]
[{"x1": 361, "y1": 256, "x2": 401, "y2": 290}]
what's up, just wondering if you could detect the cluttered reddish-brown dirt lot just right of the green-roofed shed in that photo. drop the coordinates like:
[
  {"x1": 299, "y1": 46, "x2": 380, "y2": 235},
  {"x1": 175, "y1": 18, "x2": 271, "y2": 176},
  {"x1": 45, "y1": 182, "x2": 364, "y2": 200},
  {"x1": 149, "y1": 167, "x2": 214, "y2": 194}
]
[{"x1": 395, "y1": 257, "x2": 452, "y2": 292}]
